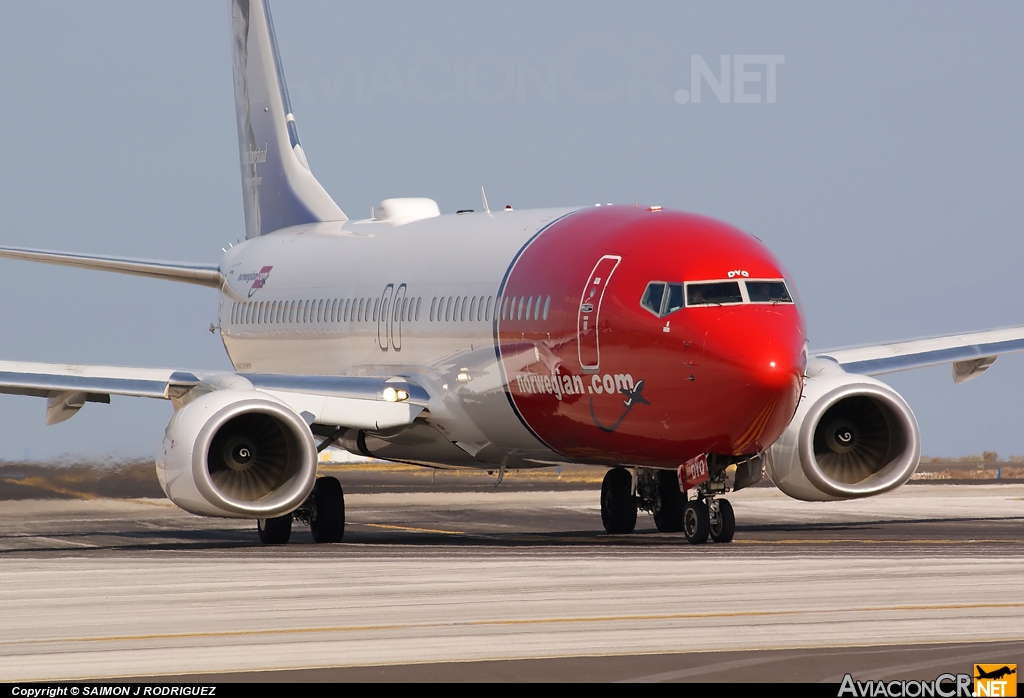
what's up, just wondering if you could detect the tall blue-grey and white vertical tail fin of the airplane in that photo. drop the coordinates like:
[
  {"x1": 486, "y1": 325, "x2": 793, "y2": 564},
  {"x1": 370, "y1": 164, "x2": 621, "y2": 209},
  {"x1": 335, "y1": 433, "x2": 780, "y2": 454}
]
[{"x1": 229, "y1": 0, "x2": 347, "y2": 237}]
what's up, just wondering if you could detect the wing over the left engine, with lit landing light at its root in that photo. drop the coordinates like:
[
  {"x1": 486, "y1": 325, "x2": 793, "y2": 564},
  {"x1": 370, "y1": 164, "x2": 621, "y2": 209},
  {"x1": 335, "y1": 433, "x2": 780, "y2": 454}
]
[{"x1": 0, "y1": 361, "x2": 430, "y2": 431}]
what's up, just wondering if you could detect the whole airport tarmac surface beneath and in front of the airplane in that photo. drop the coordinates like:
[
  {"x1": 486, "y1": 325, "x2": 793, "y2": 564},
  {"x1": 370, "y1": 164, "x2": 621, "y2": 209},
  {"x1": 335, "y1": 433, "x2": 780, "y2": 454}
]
[{"x1": 0, "y1": 484, "x2": 1024, "y2": 682}]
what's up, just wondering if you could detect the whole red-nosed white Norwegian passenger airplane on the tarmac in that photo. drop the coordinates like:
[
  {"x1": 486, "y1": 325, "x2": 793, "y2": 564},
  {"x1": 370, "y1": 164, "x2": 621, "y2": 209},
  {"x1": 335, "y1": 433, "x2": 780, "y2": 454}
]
[{"x1": 0, "y1": 0, "x2": 1024, "y2": 544}]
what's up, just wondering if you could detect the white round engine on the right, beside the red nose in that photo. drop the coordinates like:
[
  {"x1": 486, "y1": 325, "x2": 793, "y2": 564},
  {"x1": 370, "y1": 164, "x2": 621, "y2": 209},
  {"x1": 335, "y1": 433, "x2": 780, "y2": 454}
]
[{"x1": 765, "y1": 368, "x2": 921, "y2": 501}]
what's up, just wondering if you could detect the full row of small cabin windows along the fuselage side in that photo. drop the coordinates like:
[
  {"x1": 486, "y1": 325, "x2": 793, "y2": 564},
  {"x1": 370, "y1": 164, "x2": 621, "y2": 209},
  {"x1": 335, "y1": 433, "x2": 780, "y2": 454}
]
[{"x1": 231, "y1": 296, "x2": 551, "y2": 324}]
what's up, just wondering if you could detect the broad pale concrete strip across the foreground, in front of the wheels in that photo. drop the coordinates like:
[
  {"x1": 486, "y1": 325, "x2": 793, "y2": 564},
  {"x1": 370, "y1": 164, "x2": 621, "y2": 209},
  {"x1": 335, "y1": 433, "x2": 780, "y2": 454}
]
[{"x1": 0, "y1": 549, "x2": 1024, "y2": 682}]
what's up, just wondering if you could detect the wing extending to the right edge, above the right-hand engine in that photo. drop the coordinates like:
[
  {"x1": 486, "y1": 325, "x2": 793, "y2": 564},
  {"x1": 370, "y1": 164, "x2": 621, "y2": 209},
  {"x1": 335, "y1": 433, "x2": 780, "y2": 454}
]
[{"x1": 813, "y1": 326, "x2": 1024, "y2": 383}]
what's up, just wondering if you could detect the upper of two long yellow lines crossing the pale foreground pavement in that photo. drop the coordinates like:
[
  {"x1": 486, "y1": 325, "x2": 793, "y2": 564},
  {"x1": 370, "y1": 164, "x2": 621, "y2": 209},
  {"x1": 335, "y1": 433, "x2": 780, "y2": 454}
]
[{"x1": 9, "y1": 603, "x2": 1024, "y2": 646}]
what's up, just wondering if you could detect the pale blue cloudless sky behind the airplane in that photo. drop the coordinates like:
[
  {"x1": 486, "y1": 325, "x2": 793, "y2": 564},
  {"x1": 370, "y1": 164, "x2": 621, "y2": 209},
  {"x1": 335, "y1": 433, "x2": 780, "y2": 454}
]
[{"x1": 0, "y1": 0, "x2": 1024, "y2": 460}]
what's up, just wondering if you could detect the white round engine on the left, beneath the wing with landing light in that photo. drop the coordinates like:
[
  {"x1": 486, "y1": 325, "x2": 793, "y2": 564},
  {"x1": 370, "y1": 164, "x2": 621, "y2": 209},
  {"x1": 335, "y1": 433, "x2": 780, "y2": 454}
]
[{"x1": 157, "y1": 390, "x2": 317, "y2": 519}]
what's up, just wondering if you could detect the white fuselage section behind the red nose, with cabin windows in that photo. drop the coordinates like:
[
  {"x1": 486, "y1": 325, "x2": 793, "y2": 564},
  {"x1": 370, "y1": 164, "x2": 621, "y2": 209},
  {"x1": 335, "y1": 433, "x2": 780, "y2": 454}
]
[{"x1": 219, "y1": 209, "x2": 574, "y2": 467}]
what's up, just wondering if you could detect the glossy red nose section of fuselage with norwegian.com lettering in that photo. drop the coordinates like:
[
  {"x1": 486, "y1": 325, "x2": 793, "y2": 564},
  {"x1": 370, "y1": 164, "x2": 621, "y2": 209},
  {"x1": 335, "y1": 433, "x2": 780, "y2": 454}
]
[{"x1": 496, "y1": 207, "x2": 805, "y2": 467}]
